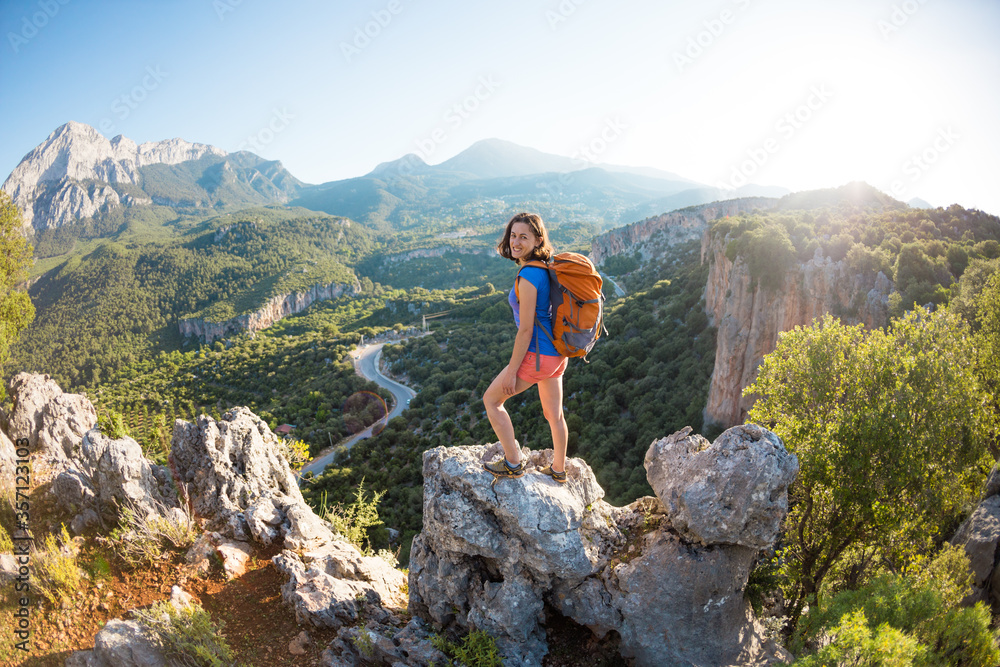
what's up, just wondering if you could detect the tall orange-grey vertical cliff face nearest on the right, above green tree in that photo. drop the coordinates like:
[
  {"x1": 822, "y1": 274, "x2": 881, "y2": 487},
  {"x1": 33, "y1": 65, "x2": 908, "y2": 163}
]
[{"x1": 701, "y1": 233, "x2": 893, "y2": 427}]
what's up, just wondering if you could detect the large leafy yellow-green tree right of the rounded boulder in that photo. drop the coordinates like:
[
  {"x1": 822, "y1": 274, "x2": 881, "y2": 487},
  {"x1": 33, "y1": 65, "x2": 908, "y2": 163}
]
[{"x1": 745, "y1": 308, "x2": 991, "y2": 626}]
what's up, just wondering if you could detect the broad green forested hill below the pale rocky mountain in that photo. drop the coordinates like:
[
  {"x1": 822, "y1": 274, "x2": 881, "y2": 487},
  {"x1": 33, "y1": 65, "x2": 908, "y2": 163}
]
[{"x1": 14, "y1": 209, "x2": 373, "y2": 388}]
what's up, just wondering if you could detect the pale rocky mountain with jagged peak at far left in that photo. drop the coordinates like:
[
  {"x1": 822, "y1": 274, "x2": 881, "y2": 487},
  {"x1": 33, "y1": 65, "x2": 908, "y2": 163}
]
[{"x1": 2, "y1": 121, "x2": 302, "y2": 233}]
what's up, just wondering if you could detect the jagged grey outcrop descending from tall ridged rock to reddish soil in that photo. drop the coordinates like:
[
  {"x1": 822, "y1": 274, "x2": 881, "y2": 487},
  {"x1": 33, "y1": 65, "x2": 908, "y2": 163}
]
[{"x1": 170, "y1": 407, "x2": 406, "y2": 628}]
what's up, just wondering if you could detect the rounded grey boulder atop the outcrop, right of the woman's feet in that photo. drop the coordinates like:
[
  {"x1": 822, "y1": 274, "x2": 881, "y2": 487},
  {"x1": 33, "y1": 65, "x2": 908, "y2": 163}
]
[{"x1": 644, "y1": 424, "x2": 799, "y2": 549}]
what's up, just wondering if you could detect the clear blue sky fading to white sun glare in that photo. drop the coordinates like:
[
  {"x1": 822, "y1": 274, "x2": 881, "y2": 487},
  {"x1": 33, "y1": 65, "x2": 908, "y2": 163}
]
[{"x1": 0, "y1": 0, "x2": 1000, "y2": 214}]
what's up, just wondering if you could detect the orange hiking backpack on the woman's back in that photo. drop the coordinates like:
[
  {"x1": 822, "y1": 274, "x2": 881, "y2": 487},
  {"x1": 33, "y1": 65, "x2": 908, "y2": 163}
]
[{"x1": 514, "y1": 252, "x2": 608, "y2": 362}]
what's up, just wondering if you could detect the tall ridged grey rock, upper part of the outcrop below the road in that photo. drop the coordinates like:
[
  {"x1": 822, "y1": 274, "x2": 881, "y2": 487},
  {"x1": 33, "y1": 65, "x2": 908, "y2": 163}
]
[{"x1": 170, "y1": 407, "x2": 304, "y2": 540}]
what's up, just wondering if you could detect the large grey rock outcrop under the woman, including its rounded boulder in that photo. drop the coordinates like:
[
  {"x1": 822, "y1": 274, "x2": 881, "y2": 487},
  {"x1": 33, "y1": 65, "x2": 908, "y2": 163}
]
[{"x1": 409, "y1": 427, "x2": 798, "y2": 666}]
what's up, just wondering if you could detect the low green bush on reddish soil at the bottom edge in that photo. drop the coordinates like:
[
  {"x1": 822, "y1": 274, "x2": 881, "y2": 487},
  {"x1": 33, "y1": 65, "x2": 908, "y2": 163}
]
[{"x1": 133, "y1": 601, "x2": 233, "y2": 667}]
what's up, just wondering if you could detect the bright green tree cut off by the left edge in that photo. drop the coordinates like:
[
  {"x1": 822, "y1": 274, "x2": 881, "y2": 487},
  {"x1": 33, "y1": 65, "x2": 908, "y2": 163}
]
[{"x1": 0, "y1": 191, "x2": 35, "y2": 396}]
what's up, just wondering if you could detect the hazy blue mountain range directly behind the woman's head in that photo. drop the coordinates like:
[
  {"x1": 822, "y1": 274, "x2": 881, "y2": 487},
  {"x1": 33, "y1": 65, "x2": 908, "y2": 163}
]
[{"x1": 291, "y1": 139, "x2": 719, "y2": 231}]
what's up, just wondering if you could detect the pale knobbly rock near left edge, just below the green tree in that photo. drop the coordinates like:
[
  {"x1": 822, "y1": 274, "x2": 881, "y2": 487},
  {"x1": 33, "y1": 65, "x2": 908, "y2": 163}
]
[{"x1": 7, "y1": 373, "x2": 97, "y2": 460}]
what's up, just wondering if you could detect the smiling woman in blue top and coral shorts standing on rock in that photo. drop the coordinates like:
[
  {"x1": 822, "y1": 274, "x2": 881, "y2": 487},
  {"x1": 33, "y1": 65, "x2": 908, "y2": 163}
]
[{"x1": 483, "y1": 213, "x2": 568, "y2": 484}]
